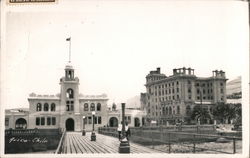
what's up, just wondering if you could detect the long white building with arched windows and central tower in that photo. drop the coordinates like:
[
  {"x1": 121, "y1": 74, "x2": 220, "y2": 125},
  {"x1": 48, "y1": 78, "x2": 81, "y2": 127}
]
[{"x1": 5, "y1": 64, "x2": 146, "y2": 131}]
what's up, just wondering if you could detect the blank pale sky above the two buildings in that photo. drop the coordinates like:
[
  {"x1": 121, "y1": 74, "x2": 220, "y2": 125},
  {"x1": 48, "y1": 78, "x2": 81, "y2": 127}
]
[{"x1": 1, "y1": 0, "x2": 249, "y2": 108}]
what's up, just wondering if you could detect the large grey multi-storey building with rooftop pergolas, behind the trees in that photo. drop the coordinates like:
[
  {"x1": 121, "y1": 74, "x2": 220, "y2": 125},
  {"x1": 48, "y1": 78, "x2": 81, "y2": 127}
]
[{"x1": 144, "y1": 67, "x2": 227, "y2": 125}]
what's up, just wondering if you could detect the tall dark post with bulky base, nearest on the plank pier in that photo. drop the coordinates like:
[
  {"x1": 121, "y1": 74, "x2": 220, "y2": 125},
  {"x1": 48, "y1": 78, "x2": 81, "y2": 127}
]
[{"x1": 119, "y1": 103, "x2": 130, "y2": 153}]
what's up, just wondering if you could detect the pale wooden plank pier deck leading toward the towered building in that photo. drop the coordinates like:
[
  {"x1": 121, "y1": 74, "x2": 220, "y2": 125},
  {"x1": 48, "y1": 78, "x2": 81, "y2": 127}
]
[{"x1": 62, "y1": 132, "x2": 162, "y2": 154}]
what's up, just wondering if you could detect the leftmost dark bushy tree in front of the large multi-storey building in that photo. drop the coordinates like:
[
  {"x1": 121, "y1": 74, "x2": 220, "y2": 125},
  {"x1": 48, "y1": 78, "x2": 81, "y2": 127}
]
[{"x1": 191, "y1": 105, "x2": 211, "y2": 123}]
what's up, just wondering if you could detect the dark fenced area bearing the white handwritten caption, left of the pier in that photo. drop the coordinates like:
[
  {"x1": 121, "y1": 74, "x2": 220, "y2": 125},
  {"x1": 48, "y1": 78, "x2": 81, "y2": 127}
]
[{"x1": 5, "y1": 129, "x2": 62, "y2": 153}]
